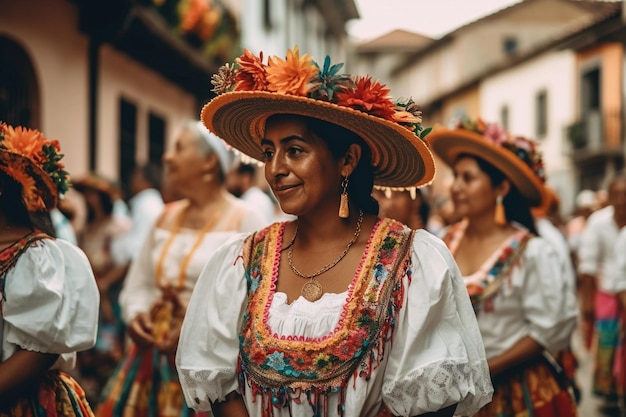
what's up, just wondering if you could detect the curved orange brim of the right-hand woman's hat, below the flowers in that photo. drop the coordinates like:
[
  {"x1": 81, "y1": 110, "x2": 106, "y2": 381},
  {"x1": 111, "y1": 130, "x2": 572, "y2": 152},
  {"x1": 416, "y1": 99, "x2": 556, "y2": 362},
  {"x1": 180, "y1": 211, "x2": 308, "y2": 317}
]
[{"x1": 428, "y1": 128, "x2": 544, "y2": 207}]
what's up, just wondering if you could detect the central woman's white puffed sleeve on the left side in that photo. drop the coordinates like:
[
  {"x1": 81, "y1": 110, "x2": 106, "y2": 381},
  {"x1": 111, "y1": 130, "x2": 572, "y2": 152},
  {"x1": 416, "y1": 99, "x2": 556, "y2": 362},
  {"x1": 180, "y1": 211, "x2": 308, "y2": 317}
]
[{"x1": 176, "y1": 234, "x2": 247, "y2": 411}]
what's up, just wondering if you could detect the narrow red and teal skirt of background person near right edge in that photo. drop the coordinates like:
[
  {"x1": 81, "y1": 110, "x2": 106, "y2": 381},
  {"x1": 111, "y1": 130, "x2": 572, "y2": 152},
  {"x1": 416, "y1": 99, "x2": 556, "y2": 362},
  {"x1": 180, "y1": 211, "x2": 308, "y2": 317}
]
[{"x1": 593, "y1": 291, "x2": 620, "y2": 401}]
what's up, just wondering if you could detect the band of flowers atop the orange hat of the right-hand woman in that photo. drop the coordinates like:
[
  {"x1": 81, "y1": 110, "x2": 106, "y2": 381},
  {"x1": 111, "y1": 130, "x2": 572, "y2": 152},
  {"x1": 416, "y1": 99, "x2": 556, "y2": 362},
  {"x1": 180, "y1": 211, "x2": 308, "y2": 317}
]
[{"x1": 455, "y1": 118, "x2": 546, "y2": 182}]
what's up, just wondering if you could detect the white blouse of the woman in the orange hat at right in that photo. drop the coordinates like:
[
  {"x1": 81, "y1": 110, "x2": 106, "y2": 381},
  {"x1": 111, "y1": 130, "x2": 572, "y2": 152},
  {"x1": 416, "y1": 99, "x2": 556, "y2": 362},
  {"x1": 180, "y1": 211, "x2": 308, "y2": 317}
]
[{"x1": 465, "y1": 237, "x2": 578, "y2": 359}]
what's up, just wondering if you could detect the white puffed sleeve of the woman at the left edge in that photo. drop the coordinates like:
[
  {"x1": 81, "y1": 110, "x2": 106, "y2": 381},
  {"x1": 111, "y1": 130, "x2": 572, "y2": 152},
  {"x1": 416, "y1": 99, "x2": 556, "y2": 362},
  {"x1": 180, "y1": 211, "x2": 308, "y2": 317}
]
[{"x1": 2, "y1": 239, "x2": 100, "y2": 354}]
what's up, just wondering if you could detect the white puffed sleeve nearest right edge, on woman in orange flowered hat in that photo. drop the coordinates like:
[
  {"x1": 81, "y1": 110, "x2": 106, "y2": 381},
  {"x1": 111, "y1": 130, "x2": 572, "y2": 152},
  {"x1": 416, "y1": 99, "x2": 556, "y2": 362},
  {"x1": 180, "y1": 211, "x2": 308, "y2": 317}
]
[{"x1": 521, "y1": 237, "x2": 578, "y2": 352}]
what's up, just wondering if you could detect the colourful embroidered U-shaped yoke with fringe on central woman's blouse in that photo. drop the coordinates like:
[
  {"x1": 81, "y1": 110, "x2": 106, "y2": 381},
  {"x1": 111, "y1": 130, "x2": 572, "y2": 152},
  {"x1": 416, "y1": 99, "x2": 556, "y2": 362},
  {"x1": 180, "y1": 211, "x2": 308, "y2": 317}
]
[{"x1": 238, "y1": 219, "x2": 413, "y2": 417}]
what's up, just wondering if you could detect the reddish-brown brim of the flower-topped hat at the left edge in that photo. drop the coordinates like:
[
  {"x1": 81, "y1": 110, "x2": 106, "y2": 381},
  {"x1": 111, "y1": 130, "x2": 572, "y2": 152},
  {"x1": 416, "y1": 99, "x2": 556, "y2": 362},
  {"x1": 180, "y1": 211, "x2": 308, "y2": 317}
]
[{"x1": 0, "y1": 150, "x2": 59, "y2": 212}]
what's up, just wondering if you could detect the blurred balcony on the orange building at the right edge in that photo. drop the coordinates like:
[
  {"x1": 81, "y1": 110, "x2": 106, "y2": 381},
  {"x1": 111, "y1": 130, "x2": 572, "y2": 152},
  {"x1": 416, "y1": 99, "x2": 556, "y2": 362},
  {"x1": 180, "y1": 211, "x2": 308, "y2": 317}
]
[{"x1": 566, "y1": 110, "x2": 624, "y2": 162}]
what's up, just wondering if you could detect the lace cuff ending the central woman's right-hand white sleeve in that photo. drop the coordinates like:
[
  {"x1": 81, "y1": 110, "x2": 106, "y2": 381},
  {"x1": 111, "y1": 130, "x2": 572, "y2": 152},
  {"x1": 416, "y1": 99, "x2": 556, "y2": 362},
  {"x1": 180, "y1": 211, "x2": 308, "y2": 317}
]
[{"x1": 382, "y1": 360, "x2": 493, "y2": 416}]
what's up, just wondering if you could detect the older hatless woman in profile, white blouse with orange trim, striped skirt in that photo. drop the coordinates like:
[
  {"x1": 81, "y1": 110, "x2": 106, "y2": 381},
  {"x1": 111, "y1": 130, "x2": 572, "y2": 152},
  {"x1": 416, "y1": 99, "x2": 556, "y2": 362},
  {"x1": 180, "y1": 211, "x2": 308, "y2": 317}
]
[{"x1": 96, "y1": 121, "x2": 264, "y2": 417}]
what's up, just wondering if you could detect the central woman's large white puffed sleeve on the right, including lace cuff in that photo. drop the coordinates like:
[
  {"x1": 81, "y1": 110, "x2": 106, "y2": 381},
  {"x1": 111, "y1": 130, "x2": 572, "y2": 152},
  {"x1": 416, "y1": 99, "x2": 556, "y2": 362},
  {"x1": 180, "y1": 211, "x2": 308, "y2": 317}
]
[{"x1": 383, "y1": 231, "x2": 493, "y2": 416}]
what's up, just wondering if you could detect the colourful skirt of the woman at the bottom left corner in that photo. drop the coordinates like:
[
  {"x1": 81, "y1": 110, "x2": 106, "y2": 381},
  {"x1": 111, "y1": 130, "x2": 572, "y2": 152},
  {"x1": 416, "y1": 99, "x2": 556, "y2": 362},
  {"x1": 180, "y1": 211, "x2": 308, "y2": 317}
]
[{"x1": 0, "y1": 371, "x2": 94, "y2": 417}]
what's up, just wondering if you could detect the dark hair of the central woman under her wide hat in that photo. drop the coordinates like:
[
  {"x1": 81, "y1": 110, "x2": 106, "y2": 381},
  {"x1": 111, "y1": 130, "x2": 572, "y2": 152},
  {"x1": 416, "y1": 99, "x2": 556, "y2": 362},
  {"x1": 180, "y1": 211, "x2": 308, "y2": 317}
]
[{"x1": 304, "y1": 117, "x2": 378, "y2": 216}]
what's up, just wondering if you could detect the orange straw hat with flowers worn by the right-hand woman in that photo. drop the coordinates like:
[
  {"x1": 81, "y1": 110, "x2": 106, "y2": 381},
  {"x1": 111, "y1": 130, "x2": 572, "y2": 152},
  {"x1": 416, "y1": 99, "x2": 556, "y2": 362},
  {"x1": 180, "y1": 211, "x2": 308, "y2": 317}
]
[{"x1": 428, "y1": 119, "x2": 545, "y2": 207}]
